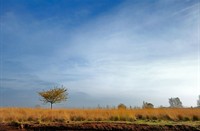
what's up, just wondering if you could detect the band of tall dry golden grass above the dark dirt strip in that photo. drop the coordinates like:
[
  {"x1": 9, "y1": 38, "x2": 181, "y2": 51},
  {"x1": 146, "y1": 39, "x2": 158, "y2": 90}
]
[{"x1": 0, "y1": 108, "x2": 200, "y2": 123}]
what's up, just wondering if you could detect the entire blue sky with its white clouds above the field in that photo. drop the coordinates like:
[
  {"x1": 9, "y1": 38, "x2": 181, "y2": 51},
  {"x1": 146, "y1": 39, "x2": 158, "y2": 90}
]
[{"x1": 0, "y1": 0, "x2": 200, "y2": 107}]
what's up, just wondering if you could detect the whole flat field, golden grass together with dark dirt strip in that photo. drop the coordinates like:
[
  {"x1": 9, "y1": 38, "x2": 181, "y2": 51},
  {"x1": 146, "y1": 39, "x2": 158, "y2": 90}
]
[{"x1": 0, "y1": 108, "x2": 200, "y2": 131}]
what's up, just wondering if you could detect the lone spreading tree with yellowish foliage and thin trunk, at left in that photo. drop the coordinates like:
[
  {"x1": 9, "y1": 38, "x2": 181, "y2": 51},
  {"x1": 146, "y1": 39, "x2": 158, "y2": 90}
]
[{"x1": 38, "y1": 86, "x2": 68, "y2": 109}]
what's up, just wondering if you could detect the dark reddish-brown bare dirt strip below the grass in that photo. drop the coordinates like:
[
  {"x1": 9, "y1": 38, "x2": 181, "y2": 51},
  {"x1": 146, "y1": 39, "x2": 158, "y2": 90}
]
[{"x1": 0, "y1": 122, "x2": 200, "y2": 131}]
